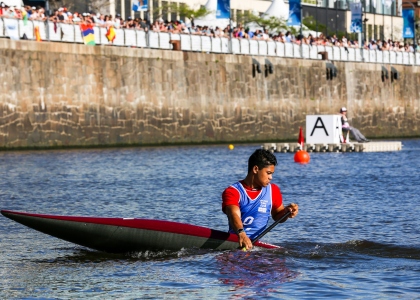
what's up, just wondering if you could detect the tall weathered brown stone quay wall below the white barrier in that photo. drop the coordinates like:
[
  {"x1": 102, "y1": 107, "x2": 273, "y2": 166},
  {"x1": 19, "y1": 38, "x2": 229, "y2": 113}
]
[{"x1": 0, "y1": 39, "x2": 420, "y2": 148}]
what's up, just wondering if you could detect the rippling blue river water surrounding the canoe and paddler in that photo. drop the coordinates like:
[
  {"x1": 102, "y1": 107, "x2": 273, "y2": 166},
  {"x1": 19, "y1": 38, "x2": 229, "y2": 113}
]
[{"x1": 0, "y1": 139, "x2": 420, "y2": 299}]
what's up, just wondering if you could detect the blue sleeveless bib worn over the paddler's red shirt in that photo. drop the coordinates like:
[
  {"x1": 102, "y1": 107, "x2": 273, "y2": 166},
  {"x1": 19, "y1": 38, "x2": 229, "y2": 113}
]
[{"x1": 228, "y1": 182, "x2": 281, "y2": 239}]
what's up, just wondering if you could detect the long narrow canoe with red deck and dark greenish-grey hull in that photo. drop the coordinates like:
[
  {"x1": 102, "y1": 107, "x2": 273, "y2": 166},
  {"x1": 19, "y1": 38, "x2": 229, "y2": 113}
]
[{"x1": 1, "y1": 210, "x2": 280, "y2": 253}]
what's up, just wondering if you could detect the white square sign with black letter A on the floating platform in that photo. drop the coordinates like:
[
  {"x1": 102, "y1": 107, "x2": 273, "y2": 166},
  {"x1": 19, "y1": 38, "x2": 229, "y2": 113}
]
[{"x1": 306, "y1": 115, "x2": 341, "y2": 144}]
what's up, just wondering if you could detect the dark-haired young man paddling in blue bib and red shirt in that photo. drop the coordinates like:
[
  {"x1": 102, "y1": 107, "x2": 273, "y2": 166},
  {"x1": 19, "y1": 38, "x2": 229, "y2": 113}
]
[{"x1": 222, "y1": 149, "x2": 299, "y2": 250}]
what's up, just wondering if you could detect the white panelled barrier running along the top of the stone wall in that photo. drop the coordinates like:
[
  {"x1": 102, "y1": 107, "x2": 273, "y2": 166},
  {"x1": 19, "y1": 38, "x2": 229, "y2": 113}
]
[{"x1": 0, "y1": 18, "x2": 420, "y2": 65}]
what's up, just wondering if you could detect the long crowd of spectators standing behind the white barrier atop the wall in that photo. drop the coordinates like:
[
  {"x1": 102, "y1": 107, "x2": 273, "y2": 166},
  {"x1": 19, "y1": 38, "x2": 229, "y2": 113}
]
[{"x1": 0, "y1": 3, "x2": 415, "y2": 52}]
